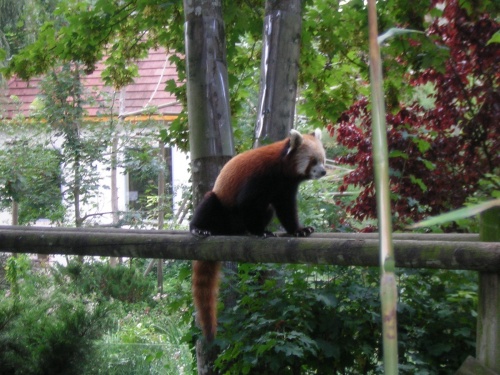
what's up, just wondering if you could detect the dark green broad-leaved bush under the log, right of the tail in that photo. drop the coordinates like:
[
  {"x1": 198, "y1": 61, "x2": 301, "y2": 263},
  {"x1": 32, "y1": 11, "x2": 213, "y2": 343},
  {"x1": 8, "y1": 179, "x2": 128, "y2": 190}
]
[{"x1": 207, "y1": 265, "x2": 477, "y2": 374}]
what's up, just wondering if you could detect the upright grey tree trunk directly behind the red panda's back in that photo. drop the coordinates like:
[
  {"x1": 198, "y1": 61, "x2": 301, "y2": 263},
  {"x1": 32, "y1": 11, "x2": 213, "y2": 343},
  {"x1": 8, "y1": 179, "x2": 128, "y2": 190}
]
[{"x1": 184, "y1": 0, "x2": 234, "y2": 374}]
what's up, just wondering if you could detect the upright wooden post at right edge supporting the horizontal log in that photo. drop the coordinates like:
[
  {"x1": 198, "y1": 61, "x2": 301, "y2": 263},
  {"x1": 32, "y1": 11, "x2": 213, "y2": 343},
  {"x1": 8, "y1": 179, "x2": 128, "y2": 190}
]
[{"x1": 476, "y1": 207, "x2": 500, "y2": 374}]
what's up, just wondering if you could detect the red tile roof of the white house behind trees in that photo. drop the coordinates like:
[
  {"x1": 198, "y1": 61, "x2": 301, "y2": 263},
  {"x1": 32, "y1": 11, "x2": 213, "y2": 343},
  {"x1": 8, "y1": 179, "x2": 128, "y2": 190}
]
[{"x1": 0, "y1": 49, "x2": 182, "y2": 119}]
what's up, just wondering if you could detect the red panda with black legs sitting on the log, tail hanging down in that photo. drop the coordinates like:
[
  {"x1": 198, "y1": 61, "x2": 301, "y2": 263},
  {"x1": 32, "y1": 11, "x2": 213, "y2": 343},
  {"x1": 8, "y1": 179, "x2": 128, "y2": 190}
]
[{"x1": 190, "y1": 129, "x2": 326, "y2": 341}]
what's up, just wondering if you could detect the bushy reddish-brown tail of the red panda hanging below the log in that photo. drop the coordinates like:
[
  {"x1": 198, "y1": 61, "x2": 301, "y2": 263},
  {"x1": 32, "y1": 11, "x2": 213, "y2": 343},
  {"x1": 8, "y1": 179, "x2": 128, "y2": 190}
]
[{"x1": 193, "y1": 261, "x2": 220, "y2": 342}]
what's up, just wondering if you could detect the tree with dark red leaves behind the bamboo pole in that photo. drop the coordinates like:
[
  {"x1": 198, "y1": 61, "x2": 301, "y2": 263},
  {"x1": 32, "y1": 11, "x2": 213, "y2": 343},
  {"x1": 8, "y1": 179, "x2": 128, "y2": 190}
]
[{"x1": 330, "y1": 0, "x2": 500, "y2": 228}]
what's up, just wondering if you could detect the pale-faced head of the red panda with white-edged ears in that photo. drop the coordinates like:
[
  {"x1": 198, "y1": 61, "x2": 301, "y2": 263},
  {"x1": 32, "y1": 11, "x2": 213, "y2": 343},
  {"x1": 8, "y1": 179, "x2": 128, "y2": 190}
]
[{"x1": 287, "y1": 129, "x2": 326, "y2": 180}]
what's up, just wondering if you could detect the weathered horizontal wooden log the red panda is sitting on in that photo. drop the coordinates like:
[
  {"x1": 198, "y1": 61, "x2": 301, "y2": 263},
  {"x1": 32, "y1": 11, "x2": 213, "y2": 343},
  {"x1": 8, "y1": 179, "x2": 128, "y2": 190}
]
[{"x1": 0, "y1": 226, "x2": 500, "y2": 272}]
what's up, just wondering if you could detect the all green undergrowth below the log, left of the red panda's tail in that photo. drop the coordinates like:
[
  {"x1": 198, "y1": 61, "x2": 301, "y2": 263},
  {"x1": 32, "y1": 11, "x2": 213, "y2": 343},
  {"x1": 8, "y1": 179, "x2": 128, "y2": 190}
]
[{"x1": 0, "y1": 255, "x2": 193, "y2": 375}]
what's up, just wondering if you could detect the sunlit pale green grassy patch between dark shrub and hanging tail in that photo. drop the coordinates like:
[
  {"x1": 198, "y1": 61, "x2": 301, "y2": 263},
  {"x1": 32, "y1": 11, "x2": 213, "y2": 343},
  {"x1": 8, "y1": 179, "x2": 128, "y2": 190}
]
[{"x1": 79, "y1": 261, "x2": 194, "y2": 375}]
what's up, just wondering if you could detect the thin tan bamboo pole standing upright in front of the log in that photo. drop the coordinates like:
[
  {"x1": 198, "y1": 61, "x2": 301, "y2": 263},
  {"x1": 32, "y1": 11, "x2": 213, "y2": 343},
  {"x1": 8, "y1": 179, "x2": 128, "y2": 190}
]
[{"x1": 368, "y1": 0, "x2": 398, "y2": 375}]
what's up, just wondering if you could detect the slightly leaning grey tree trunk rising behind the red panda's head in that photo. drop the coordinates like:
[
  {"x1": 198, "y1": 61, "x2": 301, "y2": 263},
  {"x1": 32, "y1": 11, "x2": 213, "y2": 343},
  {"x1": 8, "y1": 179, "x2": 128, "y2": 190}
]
[{"x1": 254, "y1": 0, "x2": 302, "y2": 148}]
